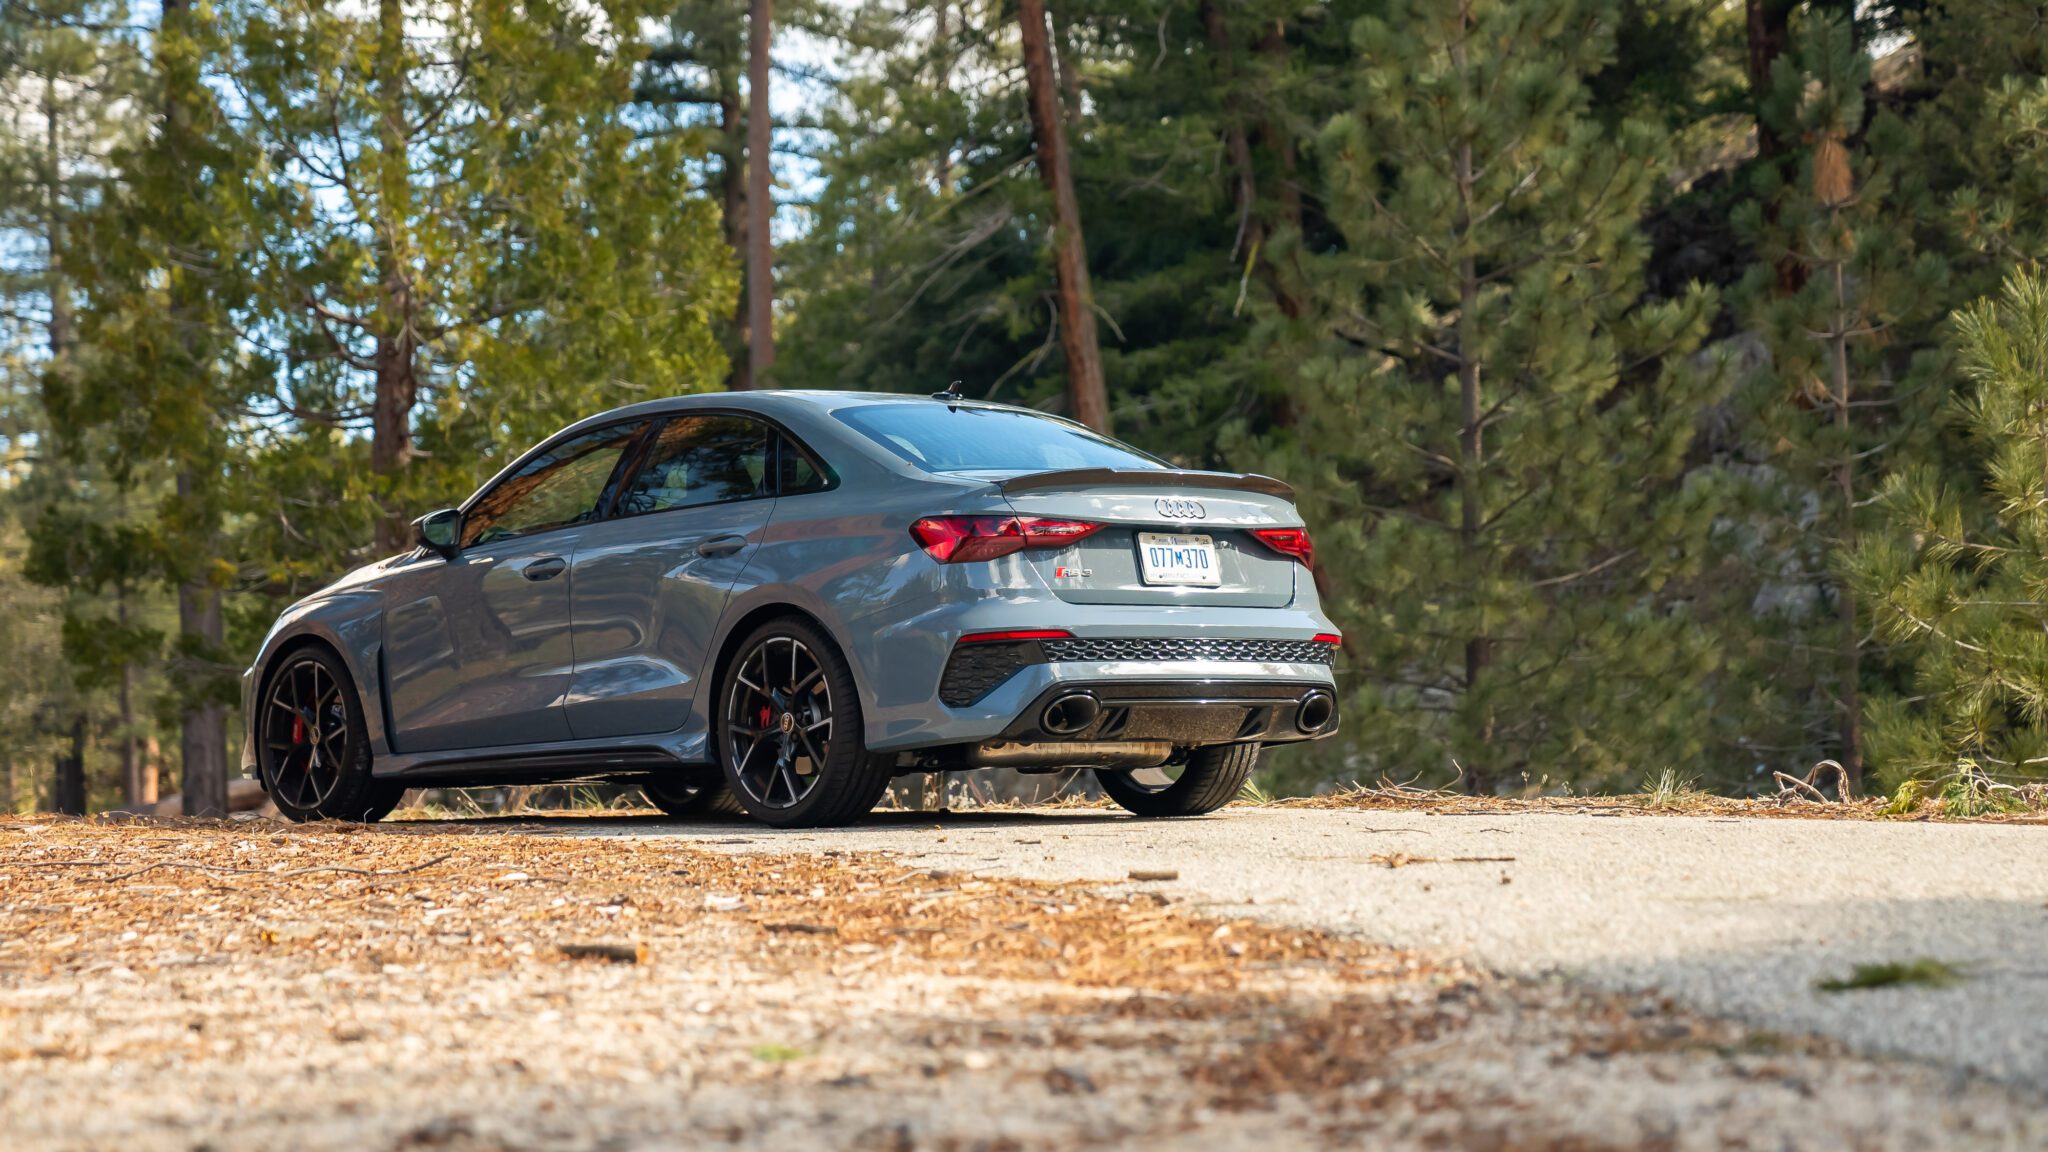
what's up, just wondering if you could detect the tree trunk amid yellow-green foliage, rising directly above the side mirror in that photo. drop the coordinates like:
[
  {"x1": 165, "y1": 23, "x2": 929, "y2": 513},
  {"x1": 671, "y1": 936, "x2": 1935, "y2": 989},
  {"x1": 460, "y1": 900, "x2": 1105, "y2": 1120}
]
[{"x1": 371, "y1": 0, "x2": 420, "y2": 553}]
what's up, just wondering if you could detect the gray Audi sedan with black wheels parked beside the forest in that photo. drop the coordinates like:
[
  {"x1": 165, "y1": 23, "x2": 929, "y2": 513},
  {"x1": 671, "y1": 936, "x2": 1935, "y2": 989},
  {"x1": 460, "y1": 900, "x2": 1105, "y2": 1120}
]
[{"x1": 242, "y1": 392, "x2": 1339, "y2": 826}]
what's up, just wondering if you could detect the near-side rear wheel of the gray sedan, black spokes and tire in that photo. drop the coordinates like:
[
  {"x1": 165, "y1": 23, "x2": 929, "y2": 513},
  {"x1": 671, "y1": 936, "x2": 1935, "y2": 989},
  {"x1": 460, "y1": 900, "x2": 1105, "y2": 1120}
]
[{"x1": 717, "y1": 617, "x2": 895, "y2": 828}]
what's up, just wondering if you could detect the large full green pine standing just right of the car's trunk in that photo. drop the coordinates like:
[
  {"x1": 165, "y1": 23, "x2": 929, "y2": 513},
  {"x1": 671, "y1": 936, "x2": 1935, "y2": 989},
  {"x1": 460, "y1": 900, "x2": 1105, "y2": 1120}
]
[{"x1": 1236, "y1": 0, "x2": 1716, "y2": 791}]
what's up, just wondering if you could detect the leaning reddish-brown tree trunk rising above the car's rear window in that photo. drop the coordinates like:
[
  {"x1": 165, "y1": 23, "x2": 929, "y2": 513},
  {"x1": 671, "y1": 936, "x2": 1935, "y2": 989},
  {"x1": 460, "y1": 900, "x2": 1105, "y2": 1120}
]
[{"x1": 1018, "y1": 0, "x2": 1110, "y2": 433}]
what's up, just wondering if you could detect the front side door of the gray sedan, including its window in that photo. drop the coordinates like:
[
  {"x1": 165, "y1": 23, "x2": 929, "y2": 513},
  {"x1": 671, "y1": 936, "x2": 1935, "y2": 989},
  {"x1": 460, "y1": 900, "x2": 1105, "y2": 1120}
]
[{"x1": 385, "y1": 420, "x2": 645, "y2": 752}]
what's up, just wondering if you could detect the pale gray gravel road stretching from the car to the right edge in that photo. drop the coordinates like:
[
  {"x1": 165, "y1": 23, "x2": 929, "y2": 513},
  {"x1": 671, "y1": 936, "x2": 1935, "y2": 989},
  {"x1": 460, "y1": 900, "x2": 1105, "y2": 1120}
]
[{"x1": 602, "y1": 808, "x2": 2048, "y2": 1088}]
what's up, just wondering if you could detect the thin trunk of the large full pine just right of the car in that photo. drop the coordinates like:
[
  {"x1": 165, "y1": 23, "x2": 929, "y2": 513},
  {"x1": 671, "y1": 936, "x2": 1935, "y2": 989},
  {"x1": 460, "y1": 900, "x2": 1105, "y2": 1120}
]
[{"x1": 1450, "y1": 8, "x2": 1493, "y2": 793}]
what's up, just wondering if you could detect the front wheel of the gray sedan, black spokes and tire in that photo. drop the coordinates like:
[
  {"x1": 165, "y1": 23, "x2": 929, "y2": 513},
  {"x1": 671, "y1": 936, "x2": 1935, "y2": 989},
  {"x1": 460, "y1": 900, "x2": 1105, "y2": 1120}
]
[{"x1": 256, "y1": 646, "x2": 393, "y2": 824}]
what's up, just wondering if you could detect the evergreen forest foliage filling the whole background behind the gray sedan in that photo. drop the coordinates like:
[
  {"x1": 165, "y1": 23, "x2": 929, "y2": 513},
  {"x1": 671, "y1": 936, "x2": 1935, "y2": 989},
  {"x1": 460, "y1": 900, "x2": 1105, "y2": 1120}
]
[{"x1": 0, "y1": 0, "x2": 2048, "y2": 806}]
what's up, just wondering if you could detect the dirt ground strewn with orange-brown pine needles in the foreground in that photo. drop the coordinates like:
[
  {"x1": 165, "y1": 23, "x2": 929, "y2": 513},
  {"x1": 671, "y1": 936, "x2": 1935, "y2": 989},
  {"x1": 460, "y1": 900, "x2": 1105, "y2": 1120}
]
[{"x1": 0, "y1": 818, "x2": 2048, "y2": 1152}]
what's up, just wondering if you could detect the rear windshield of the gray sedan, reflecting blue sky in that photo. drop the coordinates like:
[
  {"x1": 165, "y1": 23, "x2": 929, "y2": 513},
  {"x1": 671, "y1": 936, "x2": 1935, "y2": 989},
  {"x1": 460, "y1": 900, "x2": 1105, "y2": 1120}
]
[{"x1": 838, "y1": 400, "x2": 1165, "y2": 471}]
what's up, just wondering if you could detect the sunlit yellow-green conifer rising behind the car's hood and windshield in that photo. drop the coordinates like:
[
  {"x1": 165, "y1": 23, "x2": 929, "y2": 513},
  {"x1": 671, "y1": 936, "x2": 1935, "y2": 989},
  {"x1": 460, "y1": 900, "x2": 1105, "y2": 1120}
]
[{"x1": 227, "y1": 0, "x2": 733, "y2": 564}]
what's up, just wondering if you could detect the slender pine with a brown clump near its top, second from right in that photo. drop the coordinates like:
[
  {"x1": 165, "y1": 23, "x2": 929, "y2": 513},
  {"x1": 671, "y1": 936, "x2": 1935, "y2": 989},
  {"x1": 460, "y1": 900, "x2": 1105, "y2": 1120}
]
[{"x1": 1737, "y1": 14, "x2": 1946, "y2": 787}]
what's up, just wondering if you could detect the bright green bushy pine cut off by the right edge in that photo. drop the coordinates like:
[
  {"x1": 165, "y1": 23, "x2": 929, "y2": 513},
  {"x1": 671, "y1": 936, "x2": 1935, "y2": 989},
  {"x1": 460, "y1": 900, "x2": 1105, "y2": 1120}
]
[{"x1": 1851, "y1": 271, "x2": 2048, "y2": 787}]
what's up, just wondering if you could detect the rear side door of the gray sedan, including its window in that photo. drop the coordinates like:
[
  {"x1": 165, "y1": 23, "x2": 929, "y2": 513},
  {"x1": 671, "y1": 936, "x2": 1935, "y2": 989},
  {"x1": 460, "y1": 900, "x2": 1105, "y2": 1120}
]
[{"x1": 567, "y1": 414, "x2": 774, "y2": 740}]
